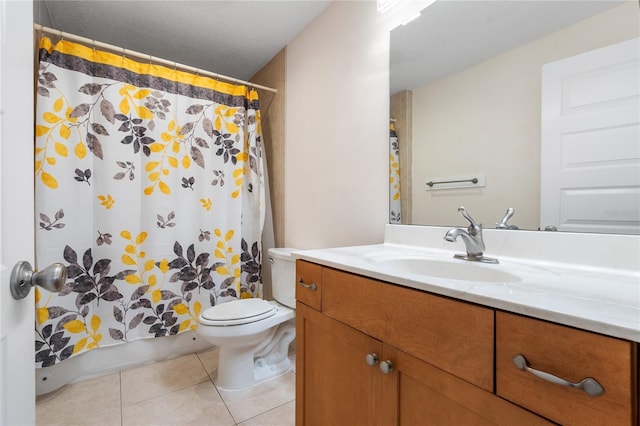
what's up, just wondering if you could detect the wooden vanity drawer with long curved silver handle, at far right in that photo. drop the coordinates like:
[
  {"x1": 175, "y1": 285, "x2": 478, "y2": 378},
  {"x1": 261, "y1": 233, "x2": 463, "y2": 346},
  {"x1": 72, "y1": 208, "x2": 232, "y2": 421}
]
[{"x1": 496, "y1": 312, "x2": 638, "y2": 425}]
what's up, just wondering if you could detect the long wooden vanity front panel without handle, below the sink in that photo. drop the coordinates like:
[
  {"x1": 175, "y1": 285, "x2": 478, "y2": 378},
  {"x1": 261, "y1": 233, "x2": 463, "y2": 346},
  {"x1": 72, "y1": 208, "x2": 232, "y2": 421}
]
[{"x1": 322, "y1": 268, "x2": 494, "y2": 392}]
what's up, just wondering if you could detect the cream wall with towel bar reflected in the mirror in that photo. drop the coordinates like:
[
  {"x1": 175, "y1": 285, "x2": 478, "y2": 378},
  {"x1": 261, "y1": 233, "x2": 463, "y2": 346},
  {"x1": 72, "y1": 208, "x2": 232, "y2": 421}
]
[{"x1": 412, "y1": 2, "x2": 640, "y2": 229}]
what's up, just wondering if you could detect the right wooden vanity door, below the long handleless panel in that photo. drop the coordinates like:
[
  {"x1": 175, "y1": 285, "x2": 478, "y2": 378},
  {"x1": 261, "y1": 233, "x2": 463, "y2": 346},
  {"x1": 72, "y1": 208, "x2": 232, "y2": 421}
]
[{"x1": 380, "y1": 344, "x2": 553, "y2": 426}]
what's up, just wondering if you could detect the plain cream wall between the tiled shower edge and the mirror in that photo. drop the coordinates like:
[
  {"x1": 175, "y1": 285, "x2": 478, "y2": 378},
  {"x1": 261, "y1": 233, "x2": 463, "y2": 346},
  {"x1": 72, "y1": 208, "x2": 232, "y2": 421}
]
[{"x1": 284, "y1": 1, "x2": 389, "y2": 249}]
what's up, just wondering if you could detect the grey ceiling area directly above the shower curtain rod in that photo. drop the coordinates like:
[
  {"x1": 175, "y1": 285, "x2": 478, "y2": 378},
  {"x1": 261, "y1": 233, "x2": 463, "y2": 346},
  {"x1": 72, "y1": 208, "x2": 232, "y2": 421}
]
[{"x1": 34, "y1": 0, "x2": 331, "y2": 80}]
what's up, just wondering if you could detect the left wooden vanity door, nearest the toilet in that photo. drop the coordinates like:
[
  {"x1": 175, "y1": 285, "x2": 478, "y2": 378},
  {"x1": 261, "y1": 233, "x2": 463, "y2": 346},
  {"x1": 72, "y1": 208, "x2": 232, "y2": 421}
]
[{"x1": 296, "y1": 302, "x2": 382, "y2": 426}]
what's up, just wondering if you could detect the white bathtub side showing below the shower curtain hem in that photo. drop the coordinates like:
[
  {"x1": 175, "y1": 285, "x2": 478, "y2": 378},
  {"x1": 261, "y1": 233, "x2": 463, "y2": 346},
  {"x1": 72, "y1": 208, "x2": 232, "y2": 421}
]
[{"x1": 36, "y1": 330, "x2": 211, "y2": 395}]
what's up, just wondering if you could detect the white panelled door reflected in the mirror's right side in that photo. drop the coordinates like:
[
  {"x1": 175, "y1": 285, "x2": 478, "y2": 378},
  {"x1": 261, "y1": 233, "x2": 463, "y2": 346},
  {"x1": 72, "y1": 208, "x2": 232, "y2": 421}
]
[{"x1": 540, "y1": 39, "x2": 640, "y2": 234}]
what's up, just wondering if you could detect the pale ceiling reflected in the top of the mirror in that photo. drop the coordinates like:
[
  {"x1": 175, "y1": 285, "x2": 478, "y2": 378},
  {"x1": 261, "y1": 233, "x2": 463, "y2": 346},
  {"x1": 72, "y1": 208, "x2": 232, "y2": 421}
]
[{"x1": 390, "y1": 0, "x2": 624, "y2": 94}]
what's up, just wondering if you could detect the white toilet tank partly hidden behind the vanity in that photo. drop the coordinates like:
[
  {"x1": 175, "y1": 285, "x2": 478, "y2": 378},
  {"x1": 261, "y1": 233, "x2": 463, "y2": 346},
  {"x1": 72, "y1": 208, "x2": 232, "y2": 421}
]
[{"x1": 268, "y1": 248, "x2": 297, "y2": 309}]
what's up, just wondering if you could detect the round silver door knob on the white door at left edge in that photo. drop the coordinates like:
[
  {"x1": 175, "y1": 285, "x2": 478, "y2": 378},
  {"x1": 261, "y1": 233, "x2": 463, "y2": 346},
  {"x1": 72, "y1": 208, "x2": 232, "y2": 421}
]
[{"x1": 9, "y1": 261, "x2": 67, "y2": 300}]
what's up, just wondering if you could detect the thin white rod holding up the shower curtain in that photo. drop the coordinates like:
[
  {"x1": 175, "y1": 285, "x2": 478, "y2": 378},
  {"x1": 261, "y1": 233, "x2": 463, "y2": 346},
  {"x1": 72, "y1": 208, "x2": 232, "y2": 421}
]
[{"x1": 33, "y1": 24, "x2": 278, "y2": 93}]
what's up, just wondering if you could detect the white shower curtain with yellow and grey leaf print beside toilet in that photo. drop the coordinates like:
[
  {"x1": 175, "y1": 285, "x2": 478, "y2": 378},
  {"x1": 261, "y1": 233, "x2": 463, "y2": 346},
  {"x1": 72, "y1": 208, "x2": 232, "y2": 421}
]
[{"x1": 35, "y1": 37, "x2": 265, "y2": 367}]
